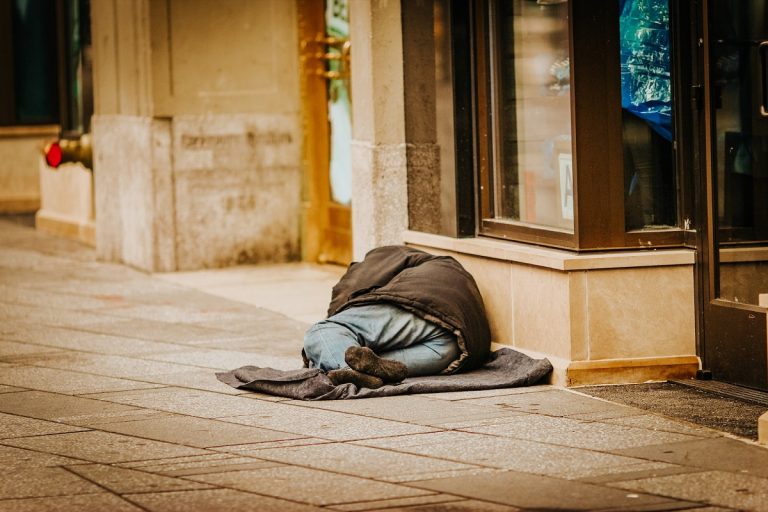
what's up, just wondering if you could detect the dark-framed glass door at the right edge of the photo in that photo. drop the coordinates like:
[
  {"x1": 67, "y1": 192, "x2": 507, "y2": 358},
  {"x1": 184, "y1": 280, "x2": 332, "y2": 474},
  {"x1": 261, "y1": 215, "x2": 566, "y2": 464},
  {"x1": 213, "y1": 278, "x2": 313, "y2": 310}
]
[{"x1": 703, "y1": 0, "x2": 768, "y2": 389}]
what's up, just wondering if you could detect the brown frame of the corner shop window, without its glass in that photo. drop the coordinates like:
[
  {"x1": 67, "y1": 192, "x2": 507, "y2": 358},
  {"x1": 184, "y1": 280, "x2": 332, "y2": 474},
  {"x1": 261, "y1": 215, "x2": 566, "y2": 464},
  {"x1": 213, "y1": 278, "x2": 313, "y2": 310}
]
[{"x1": 471, "y1": 0, "x2": 695, "y2": 251}]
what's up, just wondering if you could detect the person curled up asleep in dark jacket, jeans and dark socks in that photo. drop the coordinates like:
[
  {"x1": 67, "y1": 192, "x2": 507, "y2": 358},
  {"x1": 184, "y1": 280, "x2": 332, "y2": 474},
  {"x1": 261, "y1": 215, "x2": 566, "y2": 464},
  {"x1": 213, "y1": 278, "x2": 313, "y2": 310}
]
[{"x1": 302, "y1": 246, "x2": 491, "y2": 388}]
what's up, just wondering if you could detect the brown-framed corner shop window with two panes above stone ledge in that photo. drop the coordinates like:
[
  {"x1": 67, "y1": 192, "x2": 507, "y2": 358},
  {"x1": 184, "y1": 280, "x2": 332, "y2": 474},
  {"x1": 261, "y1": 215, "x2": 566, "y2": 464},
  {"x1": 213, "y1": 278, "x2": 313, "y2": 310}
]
[{"x1": 472, "y1": 0, "x2": 695, "y2": 251}]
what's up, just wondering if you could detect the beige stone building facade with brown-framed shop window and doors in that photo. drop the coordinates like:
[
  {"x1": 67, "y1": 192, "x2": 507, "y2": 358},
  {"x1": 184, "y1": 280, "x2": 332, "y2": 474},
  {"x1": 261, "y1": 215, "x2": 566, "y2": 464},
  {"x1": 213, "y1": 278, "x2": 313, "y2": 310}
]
[{"x1": 3, "y1": 0, "x2": 768, "y2": 389}]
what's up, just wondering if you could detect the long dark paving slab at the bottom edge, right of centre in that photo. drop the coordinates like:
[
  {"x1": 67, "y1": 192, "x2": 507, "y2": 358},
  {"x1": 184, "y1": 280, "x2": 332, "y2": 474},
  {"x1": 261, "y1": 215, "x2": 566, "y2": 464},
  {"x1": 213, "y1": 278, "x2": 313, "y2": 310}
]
[{"x1": 409, "y1": 471, "x2": 704, "y2": 510}]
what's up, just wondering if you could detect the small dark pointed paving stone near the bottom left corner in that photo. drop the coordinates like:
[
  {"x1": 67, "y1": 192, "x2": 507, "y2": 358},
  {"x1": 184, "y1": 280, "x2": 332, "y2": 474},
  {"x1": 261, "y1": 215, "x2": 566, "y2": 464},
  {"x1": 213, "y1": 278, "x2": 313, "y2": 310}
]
[{"x1": 68, "y1": 464, "x2": 211, "y2": 494}]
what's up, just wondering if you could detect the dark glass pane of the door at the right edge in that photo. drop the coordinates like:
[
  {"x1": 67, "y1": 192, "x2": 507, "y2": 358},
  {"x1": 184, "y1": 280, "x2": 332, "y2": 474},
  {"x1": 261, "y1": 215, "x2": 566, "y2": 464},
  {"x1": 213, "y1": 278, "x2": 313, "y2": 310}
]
[{"x1": 710, "y1": 0, "x2": 768, "y2": 305}]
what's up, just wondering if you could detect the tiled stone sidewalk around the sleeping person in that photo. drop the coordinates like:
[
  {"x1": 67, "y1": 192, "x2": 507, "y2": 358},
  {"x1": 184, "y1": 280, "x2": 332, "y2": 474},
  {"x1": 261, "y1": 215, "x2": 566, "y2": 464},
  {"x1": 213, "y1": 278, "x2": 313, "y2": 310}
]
[{"x1": 0, "y1": 220, "x2": 768, "y2": 512}]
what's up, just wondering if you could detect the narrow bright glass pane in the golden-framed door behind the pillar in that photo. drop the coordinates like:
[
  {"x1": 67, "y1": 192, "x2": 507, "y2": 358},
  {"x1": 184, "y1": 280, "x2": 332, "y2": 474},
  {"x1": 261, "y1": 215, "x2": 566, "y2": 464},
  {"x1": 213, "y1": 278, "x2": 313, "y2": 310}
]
[{"x1": 325, "y1": 0, "x2": 352, "y2": 205}]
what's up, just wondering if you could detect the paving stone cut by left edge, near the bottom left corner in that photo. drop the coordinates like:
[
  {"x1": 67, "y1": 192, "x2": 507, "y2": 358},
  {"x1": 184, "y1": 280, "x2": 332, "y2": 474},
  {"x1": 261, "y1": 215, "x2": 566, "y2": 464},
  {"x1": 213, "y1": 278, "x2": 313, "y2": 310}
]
[{"x1": 0, "y1": 467, "x2": 103, "y2": 500}]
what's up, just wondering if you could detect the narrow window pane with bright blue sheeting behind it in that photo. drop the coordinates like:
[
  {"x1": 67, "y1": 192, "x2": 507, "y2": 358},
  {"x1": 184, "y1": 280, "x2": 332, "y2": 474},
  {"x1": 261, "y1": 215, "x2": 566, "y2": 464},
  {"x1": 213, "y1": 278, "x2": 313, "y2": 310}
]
[{"x1": 619, "y1": 0, "x2": 677, "y2": 230}]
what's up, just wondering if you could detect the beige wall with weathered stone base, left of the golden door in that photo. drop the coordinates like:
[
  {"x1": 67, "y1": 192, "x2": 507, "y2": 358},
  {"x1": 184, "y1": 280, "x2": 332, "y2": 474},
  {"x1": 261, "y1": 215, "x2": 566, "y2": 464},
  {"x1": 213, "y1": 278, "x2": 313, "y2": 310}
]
[{"x1": 92, "y1": 0, "x2": 301, "y2": 271}]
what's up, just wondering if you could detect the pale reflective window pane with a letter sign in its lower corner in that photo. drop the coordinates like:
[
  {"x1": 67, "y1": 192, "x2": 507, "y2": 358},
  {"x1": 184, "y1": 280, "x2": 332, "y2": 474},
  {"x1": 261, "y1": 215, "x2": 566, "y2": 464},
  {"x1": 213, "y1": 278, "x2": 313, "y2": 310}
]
[{"x1": 492, "y1": 0, "x2": 573, "y2": 231}]
